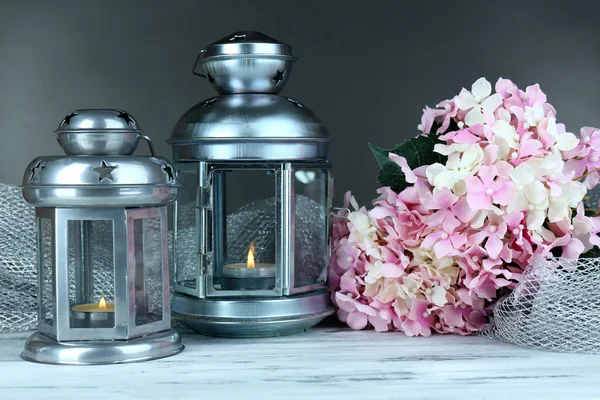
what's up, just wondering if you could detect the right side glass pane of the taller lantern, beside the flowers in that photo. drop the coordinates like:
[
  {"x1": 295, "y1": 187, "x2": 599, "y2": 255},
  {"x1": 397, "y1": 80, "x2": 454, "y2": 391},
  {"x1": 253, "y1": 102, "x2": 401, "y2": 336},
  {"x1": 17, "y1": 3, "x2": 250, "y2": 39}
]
[{"x1": 294, "y1": 167, "x2": 329, "y2": 287}]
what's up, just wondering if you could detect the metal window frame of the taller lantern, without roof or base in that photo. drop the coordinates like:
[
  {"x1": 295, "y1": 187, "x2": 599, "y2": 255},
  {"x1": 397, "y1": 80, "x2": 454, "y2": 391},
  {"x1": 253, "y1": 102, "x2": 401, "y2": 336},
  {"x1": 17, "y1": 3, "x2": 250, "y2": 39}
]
[{"x1": 173, "y1": 161, "x2": 333, "y2": 299}]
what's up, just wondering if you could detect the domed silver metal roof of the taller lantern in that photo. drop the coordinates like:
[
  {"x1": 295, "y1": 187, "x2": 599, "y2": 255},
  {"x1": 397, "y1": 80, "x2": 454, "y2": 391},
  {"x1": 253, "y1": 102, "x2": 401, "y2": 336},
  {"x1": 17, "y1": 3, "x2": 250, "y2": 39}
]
[{"x1": 167, "y1": 31, "x2": 331, "y2": 161}]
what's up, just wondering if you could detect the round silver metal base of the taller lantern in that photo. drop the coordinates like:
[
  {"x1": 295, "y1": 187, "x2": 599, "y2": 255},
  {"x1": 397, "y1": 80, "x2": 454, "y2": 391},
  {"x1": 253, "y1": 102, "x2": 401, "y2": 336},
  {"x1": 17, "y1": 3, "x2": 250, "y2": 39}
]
[{"x1": 172, "y1": 291, "x2": 334, "y2": 337}]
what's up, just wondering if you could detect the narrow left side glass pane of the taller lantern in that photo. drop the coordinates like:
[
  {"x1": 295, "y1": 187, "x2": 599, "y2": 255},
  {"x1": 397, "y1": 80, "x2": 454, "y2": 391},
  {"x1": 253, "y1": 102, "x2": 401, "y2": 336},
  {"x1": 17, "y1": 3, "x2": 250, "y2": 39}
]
[{"x1": 175, "y1": 164, "x2": 198, "y2": 289}]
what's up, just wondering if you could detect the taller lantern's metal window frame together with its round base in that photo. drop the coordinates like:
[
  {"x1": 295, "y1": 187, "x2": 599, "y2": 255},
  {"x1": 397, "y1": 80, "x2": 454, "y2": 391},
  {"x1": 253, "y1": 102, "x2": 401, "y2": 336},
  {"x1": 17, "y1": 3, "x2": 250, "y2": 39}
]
[{"x1": 173, "y1": 160, "x2": 333, "y2": 337}]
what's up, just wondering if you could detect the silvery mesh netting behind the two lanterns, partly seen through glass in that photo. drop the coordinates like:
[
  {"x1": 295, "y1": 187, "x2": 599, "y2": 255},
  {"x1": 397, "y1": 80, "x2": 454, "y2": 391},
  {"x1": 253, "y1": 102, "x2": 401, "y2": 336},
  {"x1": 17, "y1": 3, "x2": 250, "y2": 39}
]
[{"x1": 0, "y1": 184, "x2": 326, "y2": 332}]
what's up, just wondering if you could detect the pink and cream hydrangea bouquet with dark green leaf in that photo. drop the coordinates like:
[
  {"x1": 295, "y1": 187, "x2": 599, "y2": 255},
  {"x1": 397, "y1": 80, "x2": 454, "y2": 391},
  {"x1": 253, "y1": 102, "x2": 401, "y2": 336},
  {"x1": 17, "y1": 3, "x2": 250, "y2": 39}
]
[{"x1": 329, "y1": 78, "x2": 600, "y2": 336}]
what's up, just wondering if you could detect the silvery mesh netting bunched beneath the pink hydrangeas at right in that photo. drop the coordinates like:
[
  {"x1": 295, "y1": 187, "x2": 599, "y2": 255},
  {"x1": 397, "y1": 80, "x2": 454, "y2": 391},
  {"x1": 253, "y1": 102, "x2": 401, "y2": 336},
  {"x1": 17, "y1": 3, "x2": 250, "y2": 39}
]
[{"x1": 482, "y1": 258, "x2": 600, "y2": 354}]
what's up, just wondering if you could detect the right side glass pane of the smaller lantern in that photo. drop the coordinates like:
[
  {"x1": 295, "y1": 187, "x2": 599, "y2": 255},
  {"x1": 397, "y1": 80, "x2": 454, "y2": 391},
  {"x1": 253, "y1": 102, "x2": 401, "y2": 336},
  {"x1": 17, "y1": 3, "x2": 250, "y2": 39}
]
[{"x1": 133, "y1": 218, "x2": 163, "y2": 325}]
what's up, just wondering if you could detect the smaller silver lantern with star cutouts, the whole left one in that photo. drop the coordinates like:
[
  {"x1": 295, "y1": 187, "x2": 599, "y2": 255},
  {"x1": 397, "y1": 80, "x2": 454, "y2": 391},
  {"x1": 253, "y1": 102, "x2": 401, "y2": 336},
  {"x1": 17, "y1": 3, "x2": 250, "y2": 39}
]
[{"x1": 21, "y1": 110, "x2": 183, "y2": 364}]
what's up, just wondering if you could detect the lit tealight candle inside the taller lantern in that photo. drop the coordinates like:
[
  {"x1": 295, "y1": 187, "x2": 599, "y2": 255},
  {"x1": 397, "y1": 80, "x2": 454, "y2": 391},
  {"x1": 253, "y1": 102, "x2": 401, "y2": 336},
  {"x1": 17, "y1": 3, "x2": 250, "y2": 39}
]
[{"x1": 221, "y1": 243, "x2": 275, "y2": 290}]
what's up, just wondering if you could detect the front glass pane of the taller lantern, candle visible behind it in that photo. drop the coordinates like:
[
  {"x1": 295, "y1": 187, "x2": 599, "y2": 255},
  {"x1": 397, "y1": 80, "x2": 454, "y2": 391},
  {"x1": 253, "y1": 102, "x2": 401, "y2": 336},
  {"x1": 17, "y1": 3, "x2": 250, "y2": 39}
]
[{"x1": 212, "y1": 169, "x2": 280, "y2": 290}]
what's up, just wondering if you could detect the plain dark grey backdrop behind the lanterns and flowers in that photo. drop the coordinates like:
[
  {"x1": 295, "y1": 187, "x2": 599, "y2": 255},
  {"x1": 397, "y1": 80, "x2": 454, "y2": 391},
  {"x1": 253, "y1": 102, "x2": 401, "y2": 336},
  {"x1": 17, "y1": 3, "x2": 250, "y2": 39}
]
[{"x1": 0, "y1": 0, "x2": 600, "y2": 204}]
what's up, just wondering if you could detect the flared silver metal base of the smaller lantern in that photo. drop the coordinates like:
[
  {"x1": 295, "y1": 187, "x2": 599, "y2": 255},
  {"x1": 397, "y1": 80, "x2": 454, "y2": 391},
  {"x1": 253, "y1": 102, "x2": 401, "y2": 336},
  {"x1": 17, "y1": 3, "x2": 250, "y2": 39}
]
[{"x1": 21, "y1": 329, "x2": 183, "y2": 365}]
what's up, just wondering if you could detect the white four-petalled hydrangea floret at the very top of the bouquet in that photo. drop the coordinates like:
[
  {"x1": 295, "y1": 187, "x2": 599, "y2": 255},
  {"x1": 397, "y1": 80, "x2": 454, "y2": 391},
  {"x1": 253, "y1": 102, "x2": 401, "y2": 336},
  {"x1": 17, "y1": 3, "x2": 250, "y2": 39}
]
[{"x1": 456, "y1": 77, "x2": 502, "y2": 126}]
